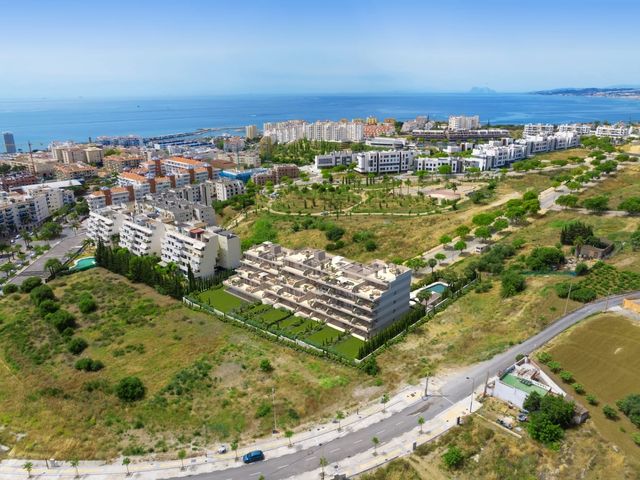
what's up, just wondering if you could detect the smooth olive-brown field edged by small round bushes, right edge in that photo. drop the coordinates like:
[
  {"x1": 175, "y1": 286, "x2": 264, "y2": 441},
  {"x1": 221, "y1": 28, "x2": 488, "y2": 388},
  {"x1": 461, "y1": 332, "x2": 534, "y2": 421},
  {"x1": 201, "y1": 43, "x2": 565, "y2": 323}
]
[{"x1": 543, "y1": 314, "x2": 640, "y2": 459}]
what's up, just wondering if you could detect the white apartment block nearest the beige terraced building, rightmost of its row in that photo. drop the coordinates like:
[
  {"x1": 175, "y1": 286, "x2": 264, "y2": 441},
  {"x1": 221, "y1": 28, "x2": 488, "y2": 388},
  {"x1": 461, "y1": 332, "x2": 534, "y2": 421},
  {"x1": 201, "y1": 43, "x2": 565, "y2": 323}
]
[{"x1": 161, "y1": 223, "x2": 240, "y2": 278}]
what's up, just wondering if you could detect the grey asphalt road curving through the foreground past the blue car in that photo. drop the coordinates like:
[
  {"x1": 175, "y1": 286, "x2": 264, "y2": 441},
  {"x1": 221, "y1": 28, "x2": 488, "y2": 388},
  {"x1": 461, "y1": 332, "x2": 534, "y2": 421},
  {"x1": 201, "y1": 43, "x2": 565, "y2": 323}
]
[{"x1": 172, "y1": 291, "x2": 640, "y2": 480}]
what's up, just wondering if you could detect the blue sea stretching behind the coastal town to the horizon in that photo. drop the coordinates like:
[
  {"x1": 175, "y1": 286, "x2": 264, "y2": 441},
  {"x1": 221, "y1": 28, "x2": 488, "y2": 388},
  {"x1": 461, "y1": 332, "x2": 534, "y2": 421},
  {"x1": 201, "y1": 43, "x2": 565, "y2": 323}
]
[{"x1": 0, "y1": 93, "x2": 640, "y2": 150}]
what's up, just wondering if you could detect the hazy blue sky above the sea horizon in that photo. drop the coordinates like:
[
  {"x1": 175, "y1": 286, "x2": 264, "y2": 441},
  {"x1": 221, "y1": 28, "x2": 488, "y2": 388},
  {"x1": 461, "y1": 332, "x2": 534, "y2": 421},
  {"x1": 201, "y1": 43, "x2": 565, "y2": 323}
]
[{"x1": 0, "y1": 0, "x2": 640, "y2": 98}]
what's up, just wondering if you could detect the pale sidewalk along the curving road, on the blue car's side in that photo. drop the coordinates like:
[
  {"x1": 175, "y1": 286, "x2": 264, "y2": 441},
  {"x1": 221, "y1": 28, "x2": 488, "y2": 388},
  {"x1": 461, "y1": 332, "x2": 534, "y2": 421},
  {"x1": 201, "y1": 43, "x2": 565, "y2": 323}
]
[{"x1": 0, "y1": 378, "x2": 450, "y2": 480}]
